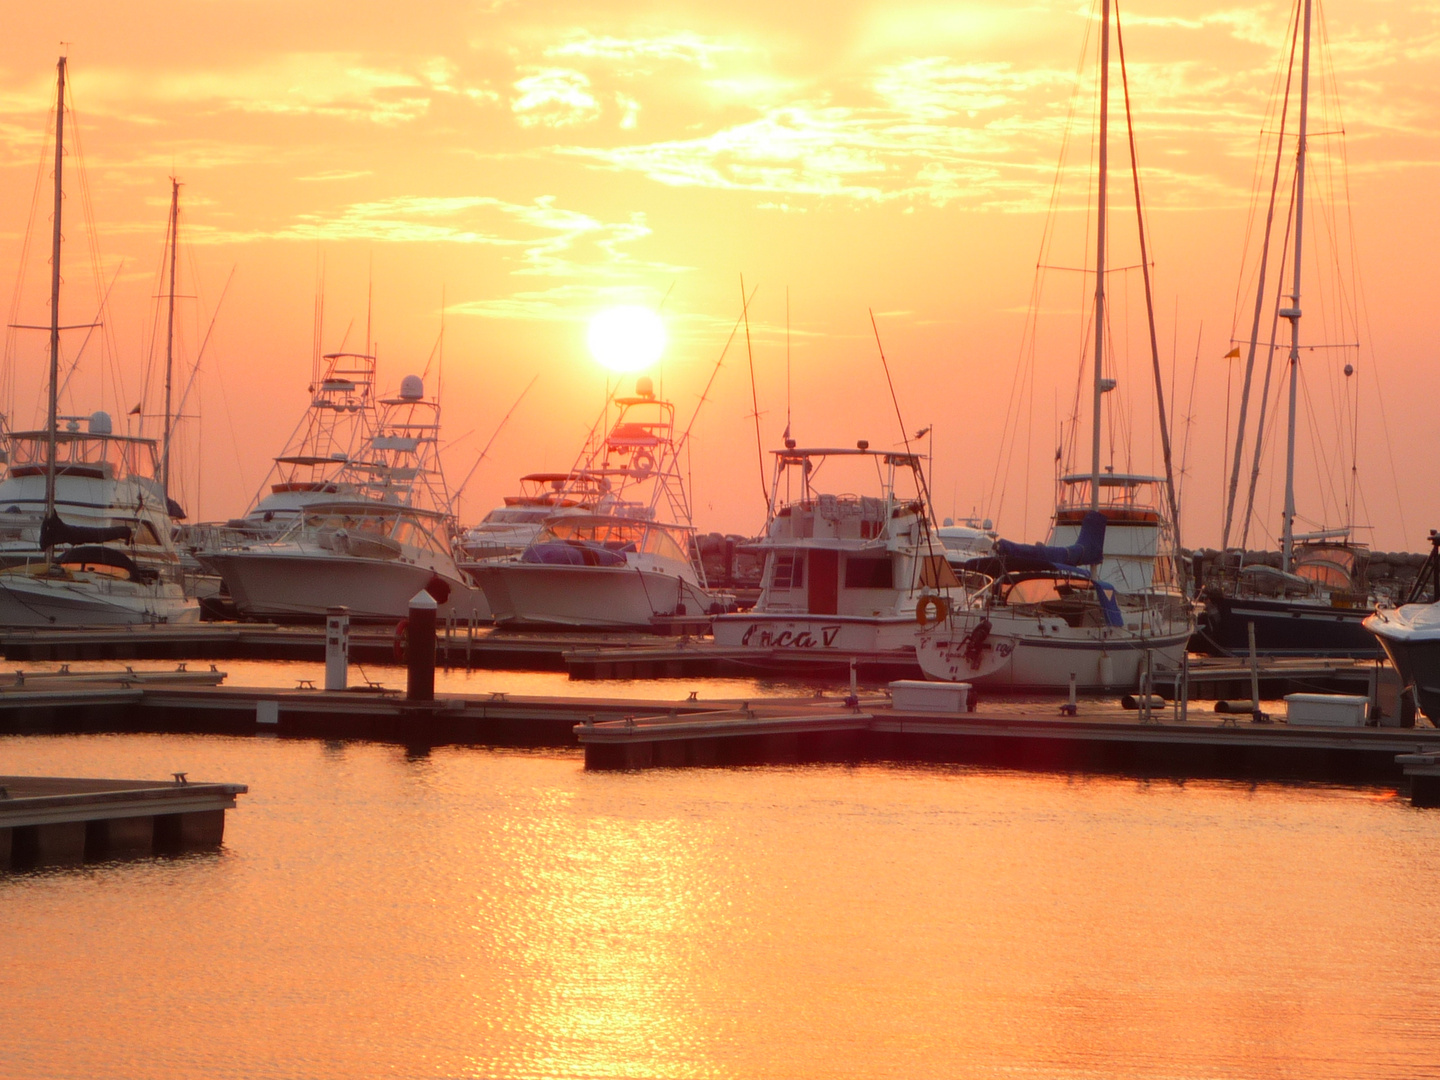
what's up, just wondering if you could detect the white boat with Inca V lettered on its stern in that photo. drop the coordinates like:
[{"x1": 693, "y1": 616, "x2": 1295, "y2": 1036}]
[{"x1": 714, "y1": 439, "x2": 994, "y2": 670}]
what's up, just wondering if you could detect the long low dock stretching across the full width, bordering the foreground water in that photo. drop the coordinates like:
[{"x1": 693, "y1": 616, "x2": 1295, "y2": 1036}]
[{"x1": 0, "y1": 672, "x2": 1440, "y2": 806}]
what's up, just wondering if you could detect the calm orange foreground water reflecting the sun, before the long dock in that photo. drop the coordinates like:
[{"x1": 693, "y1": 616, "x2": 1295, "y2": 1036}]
[{"x1": 8, "y1": 720, "x2": 1440, "y2": 1080}]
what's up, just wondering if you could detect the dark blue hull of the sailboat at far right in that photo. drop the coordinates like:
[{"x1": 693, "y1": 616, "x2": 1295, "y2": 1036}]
[{"x1": 1195, "y1": 593, "x2": 1384, "y2": 660}]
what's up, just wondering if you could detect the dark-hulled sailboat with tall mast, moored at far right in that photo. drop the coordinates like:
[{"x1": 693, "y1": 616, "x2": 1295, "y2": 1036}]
[{"x1": 1197, "y1": 0, "x2": 1380, "y2": 657}]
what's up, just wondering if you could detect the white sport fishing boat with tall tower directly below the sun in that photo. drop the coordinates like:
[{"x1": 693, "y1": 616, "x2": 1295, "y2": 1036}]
[{"x1": 472, "y1": 376, "x2": 729, "y2": 631}]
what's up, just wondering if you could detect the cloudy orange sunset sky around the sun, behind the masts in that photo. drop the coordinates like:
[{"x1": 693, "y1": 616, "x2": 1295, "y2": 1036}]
[{"x1": 0, "y1": 0, "x2": 1440, "y2": 549}]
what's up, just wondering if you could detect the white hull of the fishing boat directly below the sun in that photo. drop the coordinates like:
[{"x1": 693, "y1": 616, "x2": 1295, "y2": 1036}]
[{"x1": 474, "y1": 562, "x2": 714, "y2": 629}]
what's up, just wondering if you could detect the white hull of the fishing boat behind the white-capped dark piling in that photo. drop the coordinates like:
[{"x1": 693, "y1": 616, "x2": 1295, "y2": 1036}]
[{"x1": 202, "y1": 552, "x2": 490, "y2": 622}]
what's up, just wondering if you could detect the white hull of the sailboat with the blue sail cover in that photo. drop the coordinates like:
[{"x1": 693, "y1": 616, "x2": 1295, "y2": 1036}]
[{"x1": 916, "y1": 621, "x2": 1189, "y2": 691}]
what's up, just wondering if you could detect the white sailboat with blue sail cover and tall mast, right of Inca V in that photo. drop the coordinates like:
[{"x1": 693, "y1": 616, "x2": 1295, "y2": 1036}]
[{"x1": 916, "y1": 0, "x2": 1194, "y2": 691}]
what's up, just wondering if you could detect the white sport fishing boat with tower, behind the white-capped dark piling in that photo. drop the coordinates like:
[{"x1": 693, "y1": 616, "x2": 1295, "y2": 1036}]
[{"x1": 199, "y1": 374, "x2": 488, "y2": 622}]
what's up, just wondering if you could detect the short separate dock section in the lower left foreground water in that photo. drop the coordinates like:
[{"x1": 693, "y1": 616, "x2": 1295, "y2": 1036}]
[{"x1": 0, "y1": 773, "x2": 248, "y2": 870}]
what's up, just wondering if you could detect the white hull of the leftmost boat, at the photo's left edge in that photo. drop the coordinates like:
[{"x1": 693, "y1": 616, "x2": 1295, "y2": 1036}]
[{"x1": 0, "y1": 573, "x2": 200, "y2": 626}]
